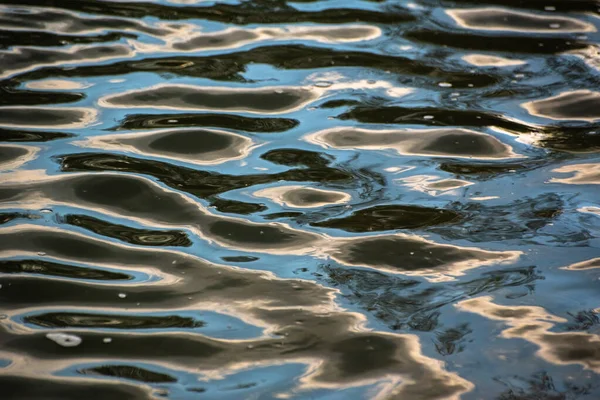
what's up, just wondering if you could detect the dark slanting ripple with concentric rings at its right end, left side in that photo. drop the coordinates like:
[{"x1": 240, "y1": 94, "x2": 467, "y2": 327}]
[{"x1": 64, "y1": 214, "x2": 192, "y2": 247}]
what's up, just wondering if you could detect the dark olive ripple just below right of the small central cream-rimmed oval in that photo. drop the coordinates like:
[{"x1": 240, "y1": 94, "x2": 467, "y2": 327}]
[{"x1": 311, "y1": 205, "x2": 461, "y2": 232}]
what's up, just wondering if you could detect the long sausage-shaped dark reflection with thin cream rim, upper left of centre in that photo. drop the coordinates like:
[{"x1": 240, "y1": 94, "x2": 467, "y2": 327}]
[{"x1": 100, "y1": 85, "x2": 316, "y2": 114}]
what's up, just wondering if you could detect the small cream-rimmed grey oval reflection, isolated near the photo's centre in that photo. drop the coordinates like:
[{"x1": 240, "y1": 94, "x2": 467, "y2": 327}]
[{"x1": 253, "y1": 186, "x2": 352, "y2": 208}]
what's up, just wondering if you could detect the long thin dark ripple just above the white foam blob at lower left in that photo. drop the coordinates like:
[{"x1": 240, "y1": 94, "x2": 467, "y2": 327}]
[{"x1": 23, "y1": 312, "x2": 206, "y2": 330}]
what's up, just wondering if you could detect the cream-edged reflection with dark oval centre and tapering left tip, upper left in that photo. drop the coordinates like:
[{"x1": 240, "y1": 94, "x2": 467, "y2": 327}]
[{"x1": 73, "y1": 129, "x2": 252, "y2": 165}]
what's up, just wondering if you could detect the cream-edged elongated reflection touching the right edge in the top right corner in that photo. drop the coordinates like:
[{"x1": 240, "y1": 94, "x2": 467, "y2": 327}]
[{"x1": 446, "y1": 7, "x2": 596, "y2": 33}]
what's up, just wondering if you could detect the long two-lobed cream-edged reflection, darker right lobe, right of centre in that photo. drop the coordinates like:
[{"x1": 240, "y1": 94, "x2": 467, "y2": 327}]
[{"x1": 305, "y1": 128, "x2": 517, "y2": 159}]
